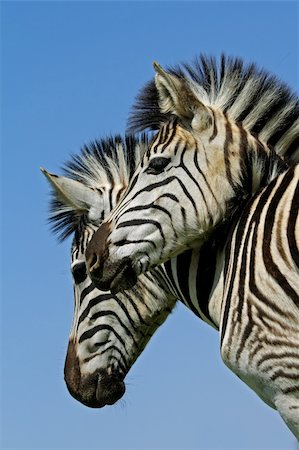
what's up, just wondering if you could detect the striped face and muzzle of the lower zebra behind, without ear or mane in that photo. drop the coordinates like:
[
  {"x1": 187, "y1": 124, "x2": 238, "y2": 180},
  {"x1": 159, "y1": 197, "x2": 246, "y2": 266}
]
[{"x1": 65, "y1": 225, "x2": 175, "y2": 408}]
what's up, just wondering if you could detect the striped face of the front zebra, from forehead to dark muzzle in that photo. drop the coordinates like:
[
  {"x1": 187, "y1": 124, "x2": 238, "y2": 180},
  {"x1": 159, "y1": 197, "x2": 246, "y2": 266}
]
[{"x1": 86, "y1": 121, "x2": 233, "y2": 292}]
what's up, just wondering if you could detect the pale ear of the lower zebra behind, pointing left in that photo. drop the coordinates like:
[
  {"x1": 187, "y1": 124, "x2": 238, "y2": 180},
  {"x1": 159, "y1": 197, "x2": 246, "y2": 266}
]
[{"x1": 41, "y1": 167, "x2": 103, "y2": 220}]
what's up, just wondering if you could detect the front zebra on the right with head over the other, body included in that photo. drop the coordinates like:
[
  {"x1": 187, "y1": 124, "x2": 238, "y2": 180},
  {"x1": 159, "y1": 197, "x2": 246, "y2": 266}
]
[{"x1": 86, "y1": 54, "x2": 299, "y2": 438}]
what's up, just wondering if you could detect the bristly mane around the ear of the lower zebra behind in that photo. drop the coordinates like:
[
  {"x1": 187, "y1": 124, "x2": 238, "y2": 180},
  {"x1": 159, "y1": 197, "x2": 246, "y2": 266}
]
[{"x1": 49, "y1": 133, "x2": 148, "y2": 242}]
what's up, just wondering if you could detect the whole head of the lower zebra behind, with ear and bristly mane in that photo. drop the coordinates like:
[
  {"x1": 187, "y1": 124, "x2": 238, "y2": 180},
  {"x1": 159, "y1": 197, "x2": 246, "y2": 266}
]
[{"x1": 42, "y1": 139, "x2": 175, "y2": 408}]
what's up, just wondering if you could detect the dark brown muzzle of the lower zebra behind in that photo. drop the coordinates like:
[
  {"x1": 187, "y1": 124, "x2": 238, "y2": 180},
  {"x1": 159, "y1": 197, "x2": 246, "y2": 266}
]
[{"x1": 64, "y1": 341, "x2": 126, "y2": 408}]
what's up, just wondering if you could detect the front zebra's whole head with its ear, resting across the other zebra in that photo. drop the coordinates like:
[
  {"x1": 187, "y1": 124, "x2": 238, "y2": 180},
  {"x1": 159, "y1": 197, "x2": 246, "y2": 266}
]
[{"x1": 86, "y1": 58, "x2": 298, "y2": 292}]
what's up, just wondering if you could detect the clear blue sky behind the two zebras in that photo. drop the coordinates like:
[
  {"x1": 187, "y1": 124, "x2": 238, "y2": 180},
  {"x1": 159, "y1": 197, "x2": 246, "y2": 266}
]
[{"x1": 1, "y1": 1, "x2": 299, "y2": 450}]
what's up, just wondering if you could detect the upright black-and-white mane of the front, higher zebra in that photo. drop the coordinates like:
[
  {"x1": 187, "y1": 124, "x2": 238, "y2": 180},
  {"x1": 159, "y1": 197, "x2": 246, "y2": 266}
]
[{"x1": 128, "y1": 55, "x2": 299, "y2": 160}]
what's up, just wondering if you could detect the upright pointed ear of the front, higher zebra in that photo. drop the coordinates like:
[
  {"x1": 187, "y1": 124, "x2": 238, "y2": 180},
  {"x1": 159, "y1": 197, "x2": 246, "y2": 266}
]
[{"x1": 153, "y1": 62, "x2": 213, "y2": 131}]
